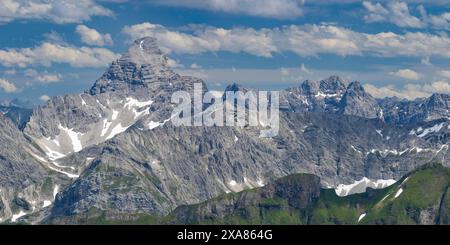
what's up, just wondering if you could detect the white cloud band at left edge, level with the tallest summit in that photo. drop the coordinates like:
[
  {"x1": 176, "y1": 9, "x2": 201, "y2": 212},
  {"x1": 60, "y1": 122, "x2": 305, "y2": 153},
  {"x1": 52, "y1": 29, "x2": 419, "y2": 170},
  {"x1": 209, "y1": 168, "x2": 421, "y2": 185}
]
[{"x1": 0, "y1": 42, "x2": 118, "y2": 68}]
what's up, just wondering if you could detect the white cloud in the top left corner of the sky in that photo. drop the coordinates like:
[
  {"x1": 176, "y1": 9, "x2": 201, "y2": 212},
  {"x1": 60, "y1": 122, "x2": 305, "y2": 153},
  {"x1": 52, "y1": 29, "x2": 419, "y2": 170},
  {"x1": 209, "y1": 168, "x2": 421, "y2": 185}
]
[{"x1": 0, "y1": 0, "x2": 114, "y2": 24}]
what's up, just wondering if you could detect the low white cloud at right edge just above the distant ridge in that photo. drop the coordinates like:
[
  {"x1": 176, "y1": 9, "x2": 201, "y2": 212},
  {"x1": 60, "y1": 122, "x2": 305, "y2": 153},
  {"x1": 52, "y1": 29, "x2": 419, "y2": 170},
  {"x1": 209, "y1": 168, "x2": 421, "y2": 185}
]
[{"x1": 364, "y1": 81, "x2": 450, "y2": 100}]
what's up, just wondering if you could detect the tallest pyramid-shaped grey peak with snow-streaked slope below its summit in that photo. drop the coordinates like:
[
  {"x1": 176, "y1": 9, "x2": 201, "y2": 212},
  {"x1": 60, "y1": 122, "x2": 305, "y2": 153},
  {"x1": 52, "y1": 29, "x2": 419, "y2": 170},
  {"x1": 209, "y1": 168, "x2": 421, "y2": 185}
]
[{"x1": 24, "y1": 38, "x2": 206, "y2": 166}]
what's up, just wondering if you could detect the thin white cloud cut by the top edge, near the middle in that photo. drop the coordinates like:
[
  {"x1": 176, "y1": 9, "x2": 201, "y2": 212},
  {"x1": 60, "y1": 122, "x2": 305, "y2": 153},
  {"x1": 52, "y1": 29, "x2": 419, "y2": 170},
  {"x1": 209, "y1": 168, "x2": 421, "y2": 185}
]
[{"x1": 155, "y1": 0, "x2": 305, "y2": 19}]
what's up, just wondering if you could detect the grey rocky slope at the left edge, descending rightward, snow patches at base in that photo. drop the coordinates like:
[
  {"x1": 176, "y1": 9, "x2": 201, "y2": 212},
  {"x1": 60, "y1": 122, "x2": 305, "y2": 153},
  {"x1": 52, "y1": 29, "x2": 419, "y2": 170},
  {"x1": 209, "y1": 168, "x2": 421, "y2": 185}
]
[{"x1": 0, "y1": 115, "x2": 67, "y2": 221}]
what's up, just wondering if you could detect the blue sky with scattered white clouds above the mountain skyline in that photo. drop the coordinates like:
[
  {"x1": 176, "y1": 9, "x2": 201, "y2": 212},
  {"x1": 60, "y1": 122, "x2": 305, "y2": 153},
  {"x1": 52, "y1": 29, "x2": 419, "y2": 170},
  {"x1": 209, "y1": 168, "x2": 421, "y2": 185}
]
[{"x1": 0, "y1": 0, "x2": 450, "y2": 103}]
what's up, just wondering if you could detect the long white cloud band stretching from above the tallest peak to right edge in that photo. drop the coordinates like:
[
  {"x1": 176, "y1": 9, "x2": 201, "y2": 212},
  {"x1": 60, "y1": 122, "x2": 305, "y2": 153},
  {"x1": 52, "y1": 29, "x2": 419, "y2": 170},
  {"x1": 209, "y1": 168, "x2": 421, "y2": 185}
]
[{"x1": 122, "y1": 22, "x2": 450, "y2": 57}]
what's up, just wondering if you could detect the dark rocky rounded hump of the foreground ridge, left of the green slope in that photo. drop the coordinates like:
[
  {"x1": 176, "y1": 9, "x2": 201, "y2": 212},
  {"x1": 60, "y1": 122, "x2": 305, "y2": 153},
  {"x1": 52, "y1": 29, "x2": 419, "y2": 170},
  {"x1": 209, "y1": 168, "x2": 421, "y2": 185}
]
[{"x1": 171, "y1": 174, "x2": 321, "y2": 224}]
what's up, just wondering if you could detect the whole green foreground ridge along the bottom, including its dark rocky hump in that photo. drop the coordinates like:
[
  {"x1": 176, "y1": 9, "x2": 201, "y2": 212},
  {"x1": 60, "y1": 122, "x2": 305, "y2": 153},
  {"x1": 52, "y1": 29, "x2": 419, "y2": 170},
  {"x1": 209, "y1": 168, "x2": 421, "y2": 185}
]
[{"x1": 44, "y1": 164, "x2": 450, "y2": 225}]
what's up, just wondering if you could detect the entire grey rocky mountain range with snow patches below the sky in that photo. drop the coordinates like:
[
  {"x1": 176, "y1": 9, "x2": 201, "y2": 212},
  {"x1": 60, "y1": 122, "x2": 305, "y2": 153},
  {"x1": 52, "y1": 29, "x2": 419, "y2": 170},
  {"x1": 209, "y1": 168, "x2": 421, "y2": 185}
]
[{"x1": 0, "y1": 38, "x2": 450, "y2": 224}]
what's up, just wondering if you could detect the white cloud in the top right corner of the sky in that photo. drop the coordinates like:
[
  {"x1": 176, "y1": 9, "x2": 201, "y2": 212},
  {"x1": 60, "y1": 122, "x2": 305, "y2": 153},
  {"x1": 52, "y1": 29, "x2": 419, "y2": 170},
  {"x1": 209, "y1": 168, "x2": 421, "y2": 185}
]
[{"x1": 363, "y1": 1, "x2": 450, "y2": 30}]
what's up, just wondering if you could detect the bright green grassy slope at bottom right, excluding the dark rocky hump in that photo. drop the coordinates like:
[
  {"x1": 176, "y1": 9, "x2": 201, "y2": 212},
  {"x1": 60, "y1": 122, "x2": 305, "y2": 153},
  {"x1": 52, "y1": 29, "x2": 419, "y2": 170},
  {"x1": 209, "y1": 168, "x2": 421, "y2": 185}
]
[{"x1": 169, "y1": 165, "x2": 450, "y2": 224}]
